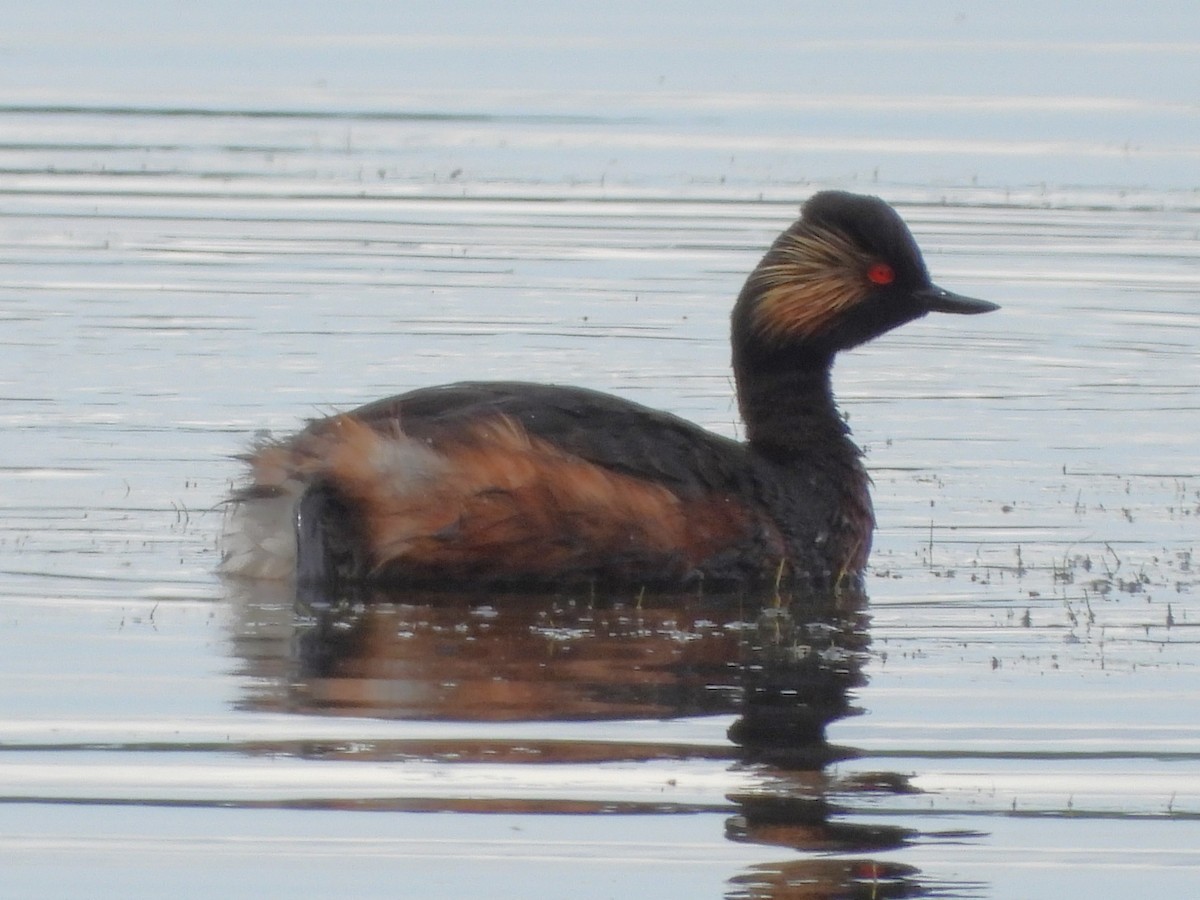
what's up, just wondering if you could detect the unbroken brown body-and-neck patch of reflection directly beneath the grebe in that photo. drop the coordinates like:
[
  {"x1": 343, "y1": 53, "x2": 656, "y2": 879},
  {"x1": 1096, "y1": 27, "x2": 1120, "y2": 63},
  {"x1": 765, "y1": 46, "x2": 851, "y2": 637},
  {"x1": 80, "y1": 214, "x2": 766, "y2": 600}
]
[{"x1": 233, "y1": 583, "x2": 868, "y2": 744}]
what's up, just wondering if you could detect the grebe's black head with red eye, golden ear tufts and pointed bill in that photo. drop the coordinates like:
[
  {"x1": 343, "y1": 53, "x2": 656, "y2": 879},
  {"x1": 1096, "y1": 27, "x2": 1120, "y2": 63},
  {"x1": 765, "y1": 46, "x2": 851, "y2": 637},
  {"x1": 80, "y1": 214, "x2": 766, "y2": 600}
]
[{"x1": 733, "y1": 191, "x2": 1000, "y2": 372}]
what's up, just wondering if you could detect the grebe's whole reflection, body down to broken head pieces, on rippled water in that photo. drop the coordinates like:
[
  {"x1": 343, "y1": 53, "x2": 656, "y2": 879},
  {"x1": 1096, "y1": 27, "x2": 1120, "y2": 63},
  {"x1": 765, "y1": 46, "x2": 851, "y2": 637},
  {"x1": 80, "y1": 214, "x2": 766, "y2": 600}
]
[{"x1": 223, "y1": 583, "x2": 924, "y2": 898}]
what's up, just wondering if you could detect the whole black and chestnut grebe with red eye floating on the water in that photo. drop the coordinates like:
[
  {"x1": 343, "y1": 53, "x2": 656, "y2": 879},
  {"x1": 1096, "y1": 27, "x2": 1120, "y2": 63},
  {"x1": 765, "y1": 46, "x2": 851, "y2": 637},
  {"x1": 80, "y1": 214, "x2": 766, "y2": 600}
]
[{"x1": 222, "y1": 191, "x2": 997, "y2": 589}]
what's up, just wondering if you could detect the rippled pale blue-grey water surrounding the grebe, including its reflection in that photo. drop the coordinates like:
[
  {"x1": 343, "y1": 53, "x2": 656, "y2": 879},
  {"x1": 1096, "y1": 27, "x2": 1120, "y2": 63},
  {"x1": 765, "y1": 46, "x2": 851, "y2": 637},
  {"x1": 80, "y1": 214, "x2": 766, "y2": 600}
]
[{"x1": 0, "y1": 6, "x2": 1200, "y2": 898}]
